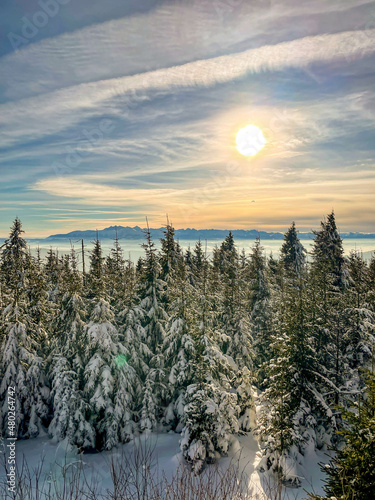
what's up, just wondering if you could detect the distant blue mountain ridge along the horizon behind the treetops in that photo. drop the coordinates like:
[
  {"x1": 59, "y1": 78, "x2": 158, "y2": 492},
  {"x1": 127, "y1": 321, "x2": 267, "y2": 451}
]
[{"x1": 46, "y1": 226, "x2": 375, "y2": 241}]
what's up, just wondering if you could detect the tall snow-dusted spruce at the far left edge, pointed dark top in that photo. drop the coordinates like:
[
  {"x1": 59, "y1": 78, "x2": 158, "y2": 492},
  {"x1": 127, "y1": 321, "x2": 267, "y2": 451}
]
[{"x1": 0, "y1": 218, "x2": 49, "y2": 437}]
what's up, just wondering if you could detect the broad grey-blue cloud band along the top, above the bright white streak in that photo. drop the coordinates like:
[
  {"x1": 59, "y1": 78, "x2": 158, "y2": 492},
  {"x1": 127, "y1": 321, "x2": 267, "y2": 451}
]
[{"x1": 0, "y1": 0, "x2": 368, "y2": 99}]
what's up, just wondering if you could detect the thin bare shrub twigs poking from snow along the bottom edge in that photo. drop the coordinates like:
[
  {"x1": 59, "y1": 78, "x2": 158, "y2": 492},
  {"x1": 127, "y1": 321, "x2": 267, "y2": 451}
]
[{"x1": 0, "y1": 439, "x2": 302, "y2": 500}]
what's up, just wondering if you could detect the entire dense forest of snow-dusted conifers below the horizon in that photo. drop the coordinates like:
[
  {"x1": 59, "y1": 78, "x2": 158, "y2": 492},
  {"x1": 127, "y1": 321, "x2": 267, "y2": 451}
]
[{"x1": 0, "y1": 213, "x2": 375, "y2": 499}]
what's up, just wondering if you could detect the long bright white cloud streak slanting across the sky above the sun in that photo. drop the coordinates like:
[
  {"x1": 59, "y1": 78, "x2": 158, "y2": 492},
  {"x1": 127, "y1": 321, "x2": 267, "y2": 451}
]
[{"x1": 0, "y1": 29, "x2": 375, "y2": 146}]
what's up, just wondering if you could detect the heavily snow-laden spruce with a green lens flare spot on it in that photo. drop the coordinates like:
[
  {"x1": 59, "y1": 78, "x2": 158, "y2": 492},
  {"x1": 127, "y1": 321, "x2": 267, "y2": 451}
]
[{"x1": 83, "y1": 240, "x2": 134, "y2": 449}]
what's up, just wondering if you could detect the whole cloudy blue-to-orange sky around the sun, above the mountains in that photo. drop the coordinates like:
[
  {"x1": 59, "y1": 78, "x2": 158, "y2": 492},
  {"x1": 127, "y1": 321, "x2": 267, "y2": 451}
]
[{"x1": 0, "y1": 0, "x2": 375, "y2": 237}]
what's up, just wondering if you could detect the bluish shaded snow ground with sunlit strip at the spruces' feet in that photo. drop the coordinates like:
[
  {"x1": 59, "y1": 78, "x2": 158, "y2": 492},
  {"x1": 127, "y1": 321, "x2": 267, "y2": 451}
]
[{"x1": 0, "y1": 433, "x2": 328, "y2": 499}]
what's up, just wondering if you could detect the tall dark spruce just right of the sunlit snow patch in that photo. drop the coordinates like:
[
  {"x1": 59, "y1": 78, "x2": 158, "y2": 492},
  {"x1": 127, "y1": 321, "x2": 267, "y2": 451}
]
[{"x1": 257, "y1": 224, "x2": 314, "y2": 484}]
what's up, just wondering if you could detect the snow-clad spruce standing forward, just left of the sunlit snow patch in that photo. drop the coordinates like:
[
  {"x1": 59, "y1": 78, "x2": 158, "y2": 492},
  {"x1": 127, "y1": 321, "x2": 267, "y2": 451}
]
[{"x1": 181, "y1": 248, "x2": 239, "y2": 473}]
